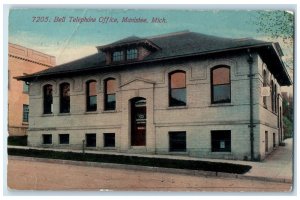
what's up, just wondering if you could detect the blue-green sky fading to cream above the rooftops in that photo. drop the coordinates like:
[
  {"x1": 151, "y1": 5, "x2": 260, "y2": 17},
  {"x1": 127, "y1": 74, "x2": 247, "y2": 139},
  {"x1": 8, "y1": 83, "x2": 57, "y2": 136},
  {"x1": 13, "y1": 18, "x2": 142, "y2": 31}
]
[{"x1": 8, "y1": 8, "x2": 293, "y2": 92}]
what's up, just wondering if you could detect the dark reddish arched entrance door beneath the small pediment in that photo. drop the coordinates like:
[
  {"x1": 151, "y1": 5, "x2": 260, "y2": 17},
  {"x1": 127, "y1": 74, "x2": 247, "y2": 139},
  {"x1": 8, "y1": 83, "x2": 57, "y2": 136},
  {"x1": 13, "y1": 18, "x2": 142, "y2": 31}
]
[{"x1": 131, "y1": 97, "x2": 147, "y2": 146}]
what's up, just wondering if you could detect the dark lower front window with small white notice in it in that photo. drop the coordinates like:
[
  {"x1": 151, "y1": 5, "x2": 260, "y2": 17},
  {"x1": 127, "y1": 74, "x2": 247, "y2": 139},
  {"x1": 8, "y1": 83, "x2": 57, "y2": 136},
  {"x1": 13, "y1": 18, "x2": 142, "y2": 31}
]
[{"x1": 210, "y1": 130, "x2": 232, "y2": 153}]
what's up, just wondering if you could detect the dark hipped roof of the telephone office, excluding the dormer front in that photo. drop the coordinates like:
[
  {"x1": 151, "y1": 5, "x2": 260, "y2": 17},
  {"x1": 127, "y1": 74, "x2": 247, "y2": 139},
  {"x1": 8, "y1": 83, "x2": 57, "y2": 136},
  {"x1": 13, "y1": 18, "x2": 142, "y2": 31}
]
[{"x1": 16, "y1": 31, "x2": 291, "y2": 85}]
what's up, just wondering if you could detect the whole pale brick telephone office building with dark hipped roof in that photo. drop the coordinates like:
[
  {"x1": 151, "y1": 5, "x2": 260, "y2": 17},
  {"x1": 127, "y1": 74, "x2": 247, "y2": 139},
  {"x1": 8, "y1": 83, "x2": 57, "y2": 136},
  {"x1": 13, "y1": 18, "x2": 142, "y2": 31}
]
[{"x1": 18, "y1": 31, "x2": 291, "y2": 160}]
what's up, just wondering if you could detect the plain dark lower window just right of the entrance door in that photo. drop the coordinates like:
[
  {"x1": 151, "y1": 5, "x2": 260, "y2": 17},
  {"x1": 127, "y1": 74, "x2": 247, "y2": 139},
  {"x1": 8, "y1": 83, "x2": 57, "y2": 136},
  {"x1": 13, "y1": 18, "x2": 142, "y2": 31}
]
[{"x1": 169, "y1": 131, "x2": 186, "y2": 152}]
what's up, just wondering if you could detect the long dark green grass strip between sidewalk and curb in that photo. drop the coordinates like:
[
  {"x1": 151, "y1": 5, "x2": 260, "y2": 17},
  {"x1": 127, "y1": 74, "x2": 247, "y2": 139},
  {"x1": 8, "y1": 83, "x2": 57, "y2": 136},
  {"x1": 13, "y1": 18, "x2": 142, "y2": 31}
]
[{"x1": 8, "y1": 148, "x2": 251, "y2": 174}]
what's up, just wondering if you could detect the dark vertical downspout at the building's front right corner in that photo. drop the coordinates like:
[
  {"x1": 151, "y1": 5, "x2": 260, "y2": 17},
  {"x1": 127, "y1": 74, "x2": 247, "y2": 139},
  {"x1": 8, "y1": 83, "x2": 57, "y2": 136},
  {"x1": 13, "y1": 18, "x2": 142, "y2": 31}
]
[{"x1": 247, "y1": 49, "x2": 254, "y2": 161}]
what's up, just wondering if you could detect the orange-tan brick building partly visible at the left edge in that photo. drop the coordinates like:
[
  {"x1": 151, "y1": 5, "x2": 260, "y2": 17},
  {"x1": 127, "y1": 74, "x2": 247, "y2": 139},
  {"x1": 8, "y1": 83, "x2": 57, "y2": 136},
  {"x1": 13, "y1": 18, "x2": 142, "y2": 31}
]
[{"x1": 8, "y1": 43, "x2": 55, "y2": 136}]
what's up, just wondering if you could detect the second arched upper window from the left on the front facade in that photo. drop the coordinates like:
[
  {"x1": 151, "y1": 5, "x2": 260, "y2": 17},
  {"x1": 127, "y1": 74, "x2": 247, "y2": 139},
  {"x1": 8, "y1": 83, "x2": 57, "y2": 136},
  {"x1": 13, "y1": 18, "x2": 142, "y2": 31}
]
[{"x1": 59, "y1": 83, "x2": 70, "y2": 113}]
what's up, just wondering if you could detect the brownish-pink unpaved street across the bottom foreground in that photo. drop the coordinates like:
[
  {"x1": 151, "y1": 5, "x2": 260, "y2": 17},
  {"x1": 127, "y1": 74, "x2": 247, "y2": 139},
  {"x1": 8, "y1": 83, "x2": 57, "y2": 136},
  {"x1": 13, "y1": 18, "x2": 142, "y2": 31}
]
[{"x1": 7, "y1": 159, "x2": 291, "y2": 192}]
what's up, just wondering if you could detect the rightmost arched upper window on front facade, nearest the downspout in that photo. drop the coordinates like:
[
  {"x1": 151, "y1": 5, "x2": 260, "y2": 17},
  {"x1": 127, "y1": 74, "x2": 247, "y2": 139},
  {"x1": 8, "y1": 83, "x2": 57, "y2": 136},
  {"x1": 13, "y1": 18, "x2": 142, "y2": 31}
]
[{"x1": 211, "y1": 66, "x2": 231, "y2": 103}]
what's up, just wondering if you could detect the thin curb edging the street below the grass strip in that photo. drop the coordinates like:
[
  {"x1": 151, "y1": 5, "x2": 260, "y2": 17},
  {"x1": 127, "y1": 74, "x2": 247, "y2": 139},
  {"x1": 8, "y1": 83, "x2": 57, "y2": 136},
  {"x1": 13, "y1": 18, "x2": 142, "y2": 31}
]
[{"x1": 8, "y1": 156, "x2": 292, "y2": 183}]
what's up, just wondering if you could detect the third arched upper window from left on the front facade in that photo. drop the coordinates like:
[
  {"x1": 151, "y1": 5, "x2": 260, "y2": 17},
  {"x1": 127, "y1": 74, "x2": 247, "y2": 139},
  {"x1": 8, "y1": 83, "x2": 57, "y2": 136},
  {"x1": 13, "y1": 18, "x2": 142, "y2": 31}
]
[{"x1": 86, "y1": 80, "x2": 97, "y2": 111}]
